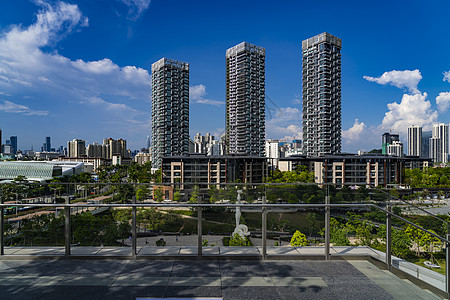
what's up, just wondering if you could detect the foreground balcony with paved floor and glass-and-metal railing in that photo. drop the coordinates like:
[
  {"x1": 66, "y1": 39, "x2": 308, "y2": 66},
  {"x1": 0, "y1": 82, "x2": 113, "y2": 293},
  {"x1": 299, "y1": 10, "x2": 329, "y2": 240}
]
[{"x1": 0, "y1": 182, "x2": 450, "y2": 299}]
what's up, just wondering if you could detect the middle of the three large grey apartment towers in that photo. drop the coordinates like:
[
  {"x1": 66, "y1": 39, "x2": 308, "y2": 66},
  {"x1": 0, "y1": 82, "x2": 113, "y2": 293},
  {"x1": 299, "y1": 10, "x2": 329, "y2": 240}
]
[{"x1": 225, "y1": 42, "x2": 266, "y2": 156}]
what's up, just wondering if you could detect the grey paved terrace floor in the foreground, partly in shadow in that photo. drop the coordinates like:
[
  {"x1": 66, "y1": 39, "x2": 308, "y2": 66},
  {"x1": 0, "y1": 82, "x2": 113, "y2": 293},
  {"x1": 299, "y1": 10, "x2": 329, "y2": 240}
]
[{"x1": 0, "y1": 247, "x2": 441, "y2": 300}]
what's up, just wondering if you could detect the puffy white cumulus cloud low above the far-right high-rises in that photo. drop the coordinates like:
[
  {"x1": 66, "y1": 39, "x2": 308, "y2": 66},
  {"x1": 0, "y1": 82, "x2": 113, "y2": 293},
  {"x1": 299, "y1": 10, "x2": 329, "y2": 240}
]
[{"x1": 380, "y1": 93, "x2": 438, "y2": 133}]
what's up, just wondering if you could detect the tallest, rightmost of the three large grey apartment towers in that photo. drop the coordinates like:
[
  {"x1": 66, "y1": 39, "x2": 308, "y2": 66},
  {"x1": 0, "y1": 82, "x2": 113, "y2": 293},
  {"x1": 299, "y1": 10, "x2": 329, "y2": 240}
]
[{"x1": 302, "y1": 32, "x2": 342, "y2": 156}]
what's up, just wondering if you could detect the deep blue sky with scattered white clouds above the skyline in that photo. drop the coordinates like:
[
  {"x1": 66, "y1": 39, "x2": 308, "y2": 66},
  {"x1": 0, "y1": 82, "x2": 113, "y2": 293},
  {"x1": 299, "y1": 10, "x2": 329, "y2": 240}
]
[{"x1": 0, "y1": 0, "x2": 450, "y2": 152}]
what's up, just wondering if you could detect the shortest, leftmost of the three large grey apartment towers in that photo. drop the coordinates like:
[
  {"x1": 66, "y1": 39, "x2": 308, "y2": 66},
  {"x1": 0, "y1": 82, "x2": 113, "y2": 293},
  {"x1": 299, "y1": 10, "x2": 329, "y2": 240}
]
[{"x1": 152, "y1": 58, "x2": 189, "y2": 168}]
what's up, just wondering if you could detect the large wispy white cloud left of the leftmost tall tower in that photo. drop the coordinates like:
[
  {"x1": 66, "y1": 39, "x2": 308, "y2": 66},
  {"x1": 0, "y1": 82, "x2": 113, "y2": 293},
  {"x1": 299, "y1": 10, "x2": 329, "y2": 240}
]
[{"x1": 0, "y1": 1, "x2": 150, "y2": 115}]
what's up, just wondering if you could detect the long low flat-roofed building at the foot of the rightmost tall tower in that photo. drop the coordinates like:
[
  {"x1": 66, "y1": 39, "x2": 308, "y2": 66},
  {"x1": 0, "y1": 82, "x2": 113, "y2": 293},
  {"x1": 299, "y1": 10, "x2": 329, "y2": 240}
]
[{"x1": 280, "y1": 154, "x2": 432, "y2": 186}]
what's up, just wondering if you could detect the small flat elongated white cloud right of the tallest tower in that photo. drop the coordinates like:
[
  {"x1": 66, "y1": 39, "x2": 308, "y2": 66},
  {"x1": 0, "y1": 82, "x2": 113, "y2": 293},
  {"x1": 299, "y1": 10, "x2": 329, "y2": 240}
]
[{"x1": 363, "y1": 70, "x2": 422, "y2": 94}]
